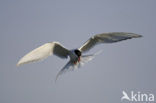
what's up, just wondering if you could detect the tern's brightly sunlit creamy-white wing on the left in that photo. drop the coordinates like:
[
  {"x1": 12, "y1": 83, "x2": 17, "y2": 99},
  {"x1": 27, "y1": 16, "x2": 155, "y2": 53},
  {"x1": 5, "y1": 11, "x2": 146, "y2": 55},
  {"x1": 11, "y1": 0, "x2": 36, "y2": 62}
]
[{"x1": 17, "y1": 42, "x2": 69, "y2": 66}]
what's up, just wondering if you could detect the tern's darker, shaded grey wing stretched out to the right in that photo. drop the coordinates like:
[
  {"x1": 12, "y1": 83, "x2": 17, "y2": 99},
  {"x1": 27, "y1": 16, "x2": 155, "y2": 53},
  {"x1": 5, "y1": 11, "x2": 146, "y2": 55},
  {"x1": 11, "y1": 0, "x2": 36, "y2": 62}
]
[{"x1": 79, "y1": 32, "x2": 141, "y2": 52}]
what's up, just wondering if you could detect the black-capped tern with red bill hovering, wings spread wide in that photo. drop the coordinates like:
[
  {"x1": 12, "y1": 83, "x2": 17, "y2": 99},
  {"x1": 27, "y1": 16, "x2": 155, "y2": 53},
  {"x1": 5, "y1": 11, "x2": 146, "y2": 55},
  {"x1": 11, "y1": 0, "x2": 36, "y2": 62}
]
[{"x1": 17, "y1": 32, "x2": 142, "y2": 80}]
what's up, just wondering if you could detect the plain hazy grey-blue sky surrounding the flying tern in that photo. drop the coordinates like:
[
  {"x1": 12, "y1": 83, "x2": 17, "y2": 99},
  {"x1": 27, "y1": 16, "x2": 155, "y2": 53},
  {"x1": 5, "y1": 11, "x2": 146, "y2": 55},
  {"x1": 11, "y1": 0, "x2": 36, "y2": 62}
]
[{"x1": 0, "y1": 0, "x2": 156, "y2": 103}]
